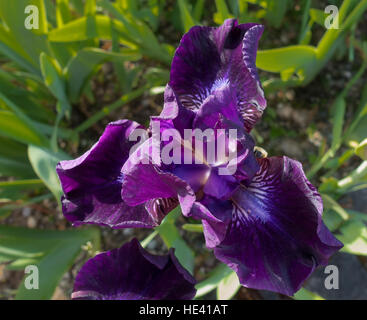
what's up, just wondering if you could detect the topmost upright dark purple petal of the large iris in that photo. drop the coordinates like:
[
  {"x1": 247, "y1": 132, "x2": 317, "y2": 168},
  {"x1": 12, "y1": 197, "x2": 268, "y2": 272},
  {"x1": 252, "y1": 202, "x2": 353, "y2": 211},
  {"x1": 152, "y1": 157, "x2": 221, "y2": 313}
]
[{"x1": 169, "y1": 19, "x2": 266, "y2": 131}]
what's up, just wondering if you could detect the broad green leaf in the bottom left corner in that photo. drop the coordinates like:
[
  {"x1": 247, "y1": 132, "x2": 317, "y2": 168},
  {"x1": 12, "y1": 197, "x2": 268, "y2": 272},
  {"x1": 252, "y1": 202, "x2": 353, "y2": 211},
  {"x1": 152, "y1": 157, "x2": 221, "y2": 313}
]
[{"x1": 0, "y1": 225, "x2": 99, "y2": 300}]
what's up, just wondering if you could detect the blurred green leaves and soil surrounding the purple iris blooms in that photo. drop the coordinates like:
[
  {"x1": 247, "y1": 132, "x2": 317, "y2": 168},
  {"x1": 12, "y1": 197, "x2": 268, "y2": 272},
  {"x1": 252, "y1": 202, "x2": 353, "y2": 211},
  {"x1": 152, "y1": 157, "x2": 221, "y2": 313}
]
[{"x1": 0, "y1": 0, "x2": 367, "y2": 299}]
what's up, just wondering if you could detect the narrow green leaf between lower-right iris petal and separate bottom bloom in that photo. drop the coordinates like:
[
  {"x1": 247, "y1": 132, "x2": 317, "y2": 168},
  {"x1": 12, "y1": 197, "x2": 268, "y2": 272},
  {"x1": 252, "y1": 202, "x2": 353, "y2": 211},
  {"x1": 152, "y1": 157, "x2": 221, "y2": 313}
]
[{"x1": 156, "y1": 209, "x2": 198, "y2": 274}]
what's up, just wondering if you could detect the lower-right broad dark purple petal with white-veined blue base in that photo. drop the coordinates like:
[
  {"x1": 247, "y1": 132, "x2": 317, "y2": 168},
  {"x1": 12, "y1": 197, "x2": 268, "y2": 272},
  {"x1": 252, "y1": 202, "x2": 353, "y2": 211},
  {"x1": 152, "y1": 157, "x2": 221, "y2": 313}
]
[{"x1": 208, "y1": 157, "x2": 343, "y2": 296}]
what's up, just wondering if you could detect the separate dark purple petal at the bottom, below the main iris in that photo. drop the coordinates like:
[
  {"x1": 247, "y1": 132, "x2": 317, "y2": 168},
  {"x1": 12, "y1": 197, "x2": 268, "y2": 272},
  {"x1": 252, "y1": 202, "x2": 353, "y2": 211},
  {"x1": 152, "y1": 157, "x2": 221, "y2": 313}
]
[{"x1": 72, "y1": 239, "x2": 196, "y2": 300}]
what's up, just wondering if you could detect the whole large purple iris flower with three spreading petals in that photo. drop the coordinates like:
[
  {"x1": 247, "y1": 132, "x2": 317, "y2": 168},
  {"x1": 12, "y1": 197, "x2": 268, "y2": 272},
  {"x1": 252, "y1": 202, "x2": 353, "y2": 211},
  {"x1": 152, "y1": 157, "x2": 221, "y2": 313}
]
[{"x1": 57, "y1": 20, "x2": 342, "y2": 297}]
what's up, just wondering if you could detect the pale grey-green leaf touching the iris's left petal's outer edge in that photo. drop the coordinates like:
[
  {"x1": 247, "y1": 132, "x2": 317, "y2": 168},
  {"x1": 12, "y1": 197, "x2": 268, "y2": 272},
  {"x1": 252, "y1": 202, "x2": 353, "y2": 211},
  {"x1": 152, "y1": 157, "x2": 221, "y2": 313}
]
[{"x1": 28, "y1": 145, "x2": 70, "y2": 201}]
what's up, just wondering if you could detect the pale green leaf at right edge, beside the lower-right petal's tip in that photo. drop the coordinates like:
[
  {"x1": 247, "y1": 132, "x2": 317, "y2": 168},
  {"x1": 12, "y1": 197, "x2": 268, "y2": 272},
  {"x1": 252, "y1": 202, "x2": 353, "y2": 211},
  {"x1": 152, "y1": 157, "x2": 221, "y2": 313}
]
[{"x1": 336, "y1": 219, "x2": 367, "y2": 256}]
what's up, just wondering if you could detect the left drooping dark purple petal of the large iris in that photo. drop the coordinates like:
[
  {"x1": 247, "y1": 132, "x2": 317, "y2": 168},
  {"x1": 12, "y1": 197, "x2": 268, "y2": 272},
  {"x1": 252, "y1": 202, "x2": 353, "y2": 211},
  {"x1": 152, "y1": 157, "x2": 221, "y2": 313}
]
[{"x1": 56, "y1": 120, "x2": 162, "y2": 228}]
